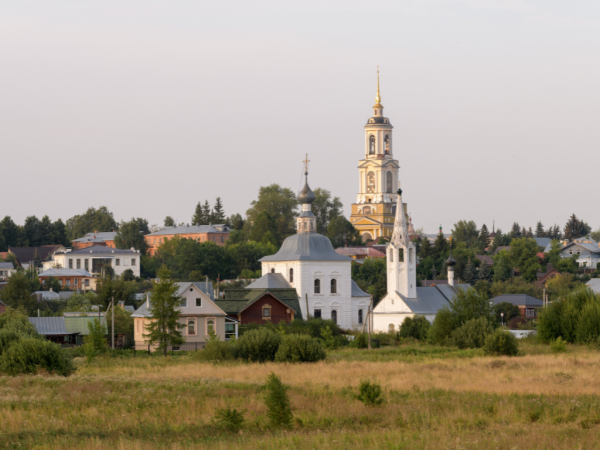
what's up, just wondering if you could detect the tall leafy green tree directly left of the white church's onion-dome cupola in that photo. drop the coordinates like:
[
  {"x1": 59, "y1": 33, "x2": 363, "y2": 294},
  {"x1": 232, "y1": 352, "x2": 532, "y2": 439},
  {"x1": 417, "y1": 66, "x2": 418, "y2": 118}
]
[{"x1": 246, "y1": 184, "x2": 298, "y2": 241}]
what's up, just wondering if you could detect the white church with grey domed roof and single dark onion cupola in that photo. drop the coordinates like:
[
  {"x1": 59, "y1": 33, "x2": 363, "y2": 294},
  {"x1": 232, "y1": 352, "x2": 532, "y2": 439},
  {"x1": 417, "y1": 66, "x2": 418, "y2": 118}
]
[{"x1": 260, "y1": 167, "x2": 370, "y2": 329}]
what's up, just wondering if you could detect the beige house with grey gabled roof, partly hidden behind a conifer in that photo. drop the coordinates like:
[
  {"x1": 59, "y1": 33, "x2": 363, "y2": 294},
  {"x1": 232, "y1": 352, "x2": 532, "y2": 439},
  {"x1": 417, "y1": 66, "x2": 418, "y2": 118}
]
[{"x1": 131, "y1": 281, "x2": 237, "y2": 351}]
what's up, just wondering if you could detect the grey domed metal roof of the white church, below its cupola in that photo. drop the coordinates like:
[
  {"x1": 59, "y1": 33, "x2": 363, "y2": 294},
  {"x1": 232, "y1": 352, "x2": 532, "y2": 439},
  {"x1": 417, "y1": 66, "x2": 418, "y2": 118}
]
[{"x1": 260, "y1": 233, "x2": 352, "y2": 262}]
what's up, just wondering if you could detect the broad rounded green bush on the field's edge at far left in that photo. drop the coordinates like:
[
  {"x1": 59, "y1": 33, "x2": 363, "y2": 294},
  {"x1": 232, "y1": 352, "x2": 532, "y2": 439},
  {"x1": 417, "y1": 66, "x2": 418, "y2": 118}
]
[{"x1": 0, "y1": 337, "x2": 75, "y2": 376}]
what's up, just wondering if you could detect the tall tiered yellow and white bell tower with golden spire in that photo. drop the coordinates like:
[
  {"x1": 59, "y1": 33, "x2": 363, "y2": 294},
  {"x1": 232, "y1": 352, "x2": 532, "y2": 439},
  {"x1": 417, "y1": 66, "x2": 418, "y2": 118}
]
[{"x1": 350, "y1": 67, "x2": 406, "y2": 242}]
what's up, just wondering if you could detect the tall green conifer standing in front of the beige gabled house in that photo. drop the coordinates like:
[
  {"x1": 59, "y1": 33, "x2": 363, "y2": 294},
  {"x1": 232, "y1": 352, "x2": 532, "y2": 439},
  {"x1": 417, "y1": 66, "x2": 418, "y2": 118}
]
[{"x1": 144, "y1": 266, "x2": 185, "y2": 356}]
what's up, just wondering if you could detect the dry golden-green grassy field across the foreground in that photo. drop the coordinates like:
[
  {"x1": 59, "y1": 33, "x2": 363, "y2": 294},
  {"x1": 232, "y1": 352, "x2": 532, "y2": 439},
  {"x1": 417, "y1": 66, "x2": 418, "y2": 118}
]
[{"x1": 0, "y1": 343, "x2": 600, "y2": 450}]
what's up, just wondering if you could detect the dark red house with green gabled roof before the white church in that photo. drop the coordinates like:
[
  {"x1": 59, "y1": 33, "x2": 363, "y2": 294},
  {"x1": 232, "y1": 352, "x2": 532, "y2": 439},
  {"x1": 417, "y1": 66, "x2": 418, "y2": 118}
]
[{"x1": 215, "y1": 273, "x2": 302, "y2": 325}]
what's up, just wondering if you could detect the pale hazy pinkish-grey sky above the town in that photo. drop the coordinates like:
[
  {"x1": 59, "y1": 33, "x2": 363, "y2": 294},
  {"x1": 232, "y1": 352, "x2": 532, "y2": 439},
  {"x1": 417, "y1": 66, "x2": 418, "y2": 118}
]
[{"x1": 0, "y1": 0, "x2": 600, "y2": 233}]
